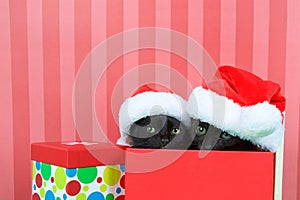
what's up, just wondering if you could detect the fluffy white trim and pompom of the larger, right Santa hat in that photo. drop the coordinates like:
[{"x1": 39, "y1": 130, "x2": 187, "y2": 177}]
[{"x1": 187, "y1": 86, "x2": 284, "y2": 152}]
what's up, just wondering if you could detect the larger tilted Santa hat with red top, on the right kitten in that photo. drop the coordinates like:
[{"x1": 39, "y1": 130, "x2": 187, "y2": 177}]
[{"x1": 187, "y1": 66, "x2": 285, "y2": 152}]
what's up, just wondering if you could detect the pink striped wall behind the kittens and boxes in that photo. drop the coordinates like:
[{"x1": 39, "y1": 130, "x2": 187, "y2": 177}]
[{"x1": 0, "y1": 0, "x2": 300, "y2": 200}]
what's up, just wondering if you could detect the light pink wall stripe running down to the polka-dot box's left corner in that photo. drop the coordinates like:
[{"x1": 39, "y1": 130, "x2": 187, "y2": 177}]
[{"x1": 27, "y1": 0, "x2": 45, "y2": 142}]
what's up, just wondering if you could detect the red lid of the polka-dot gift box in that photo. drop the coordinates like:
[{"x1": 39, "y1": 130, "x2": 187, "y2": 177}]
[{"x1": 31, "y1": 142, "x2": 125, "y2": 168}]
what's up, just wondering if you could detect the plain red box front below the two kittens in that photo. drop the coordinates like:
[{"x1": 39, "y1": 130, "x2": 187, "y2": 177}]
[{"x1": 125, "y1": 149, "x2": 275, "y2": 200}]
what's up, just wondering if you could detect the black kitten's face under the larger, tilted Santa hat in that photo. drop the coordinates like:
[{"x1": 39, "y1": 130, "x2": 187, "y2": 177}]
[{"x1": 189, "y1": 119, "x2": 259, "y2": 151}]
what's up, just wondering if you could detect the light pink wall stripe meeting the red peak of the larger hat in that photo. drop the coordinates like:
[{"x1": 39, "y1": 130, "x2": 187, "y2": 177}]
[{"x1": 220, "y1": 0, "x2": 236, "y2": 66}]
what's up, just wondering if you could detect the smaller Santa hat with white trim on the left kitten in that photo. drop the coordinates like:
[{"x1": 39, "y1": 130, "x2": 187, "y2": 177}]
[{"x1": 117, "y1": 85, "x2": 190, "y2": 146}]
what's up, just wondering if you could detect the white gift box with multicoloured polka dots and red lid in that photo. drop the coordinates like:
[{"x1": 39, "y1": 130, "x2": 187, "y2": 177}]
[{"x1": 31, "y1": 142, "x2": 125, "y2": 200}]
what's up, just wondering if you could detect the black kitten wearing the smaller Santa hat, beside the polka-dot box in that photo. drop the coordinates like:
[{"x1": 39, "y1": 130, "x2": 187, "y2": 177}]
[{"x1": 129, "y1": 115, "x2": 192, "y2": 149}]
